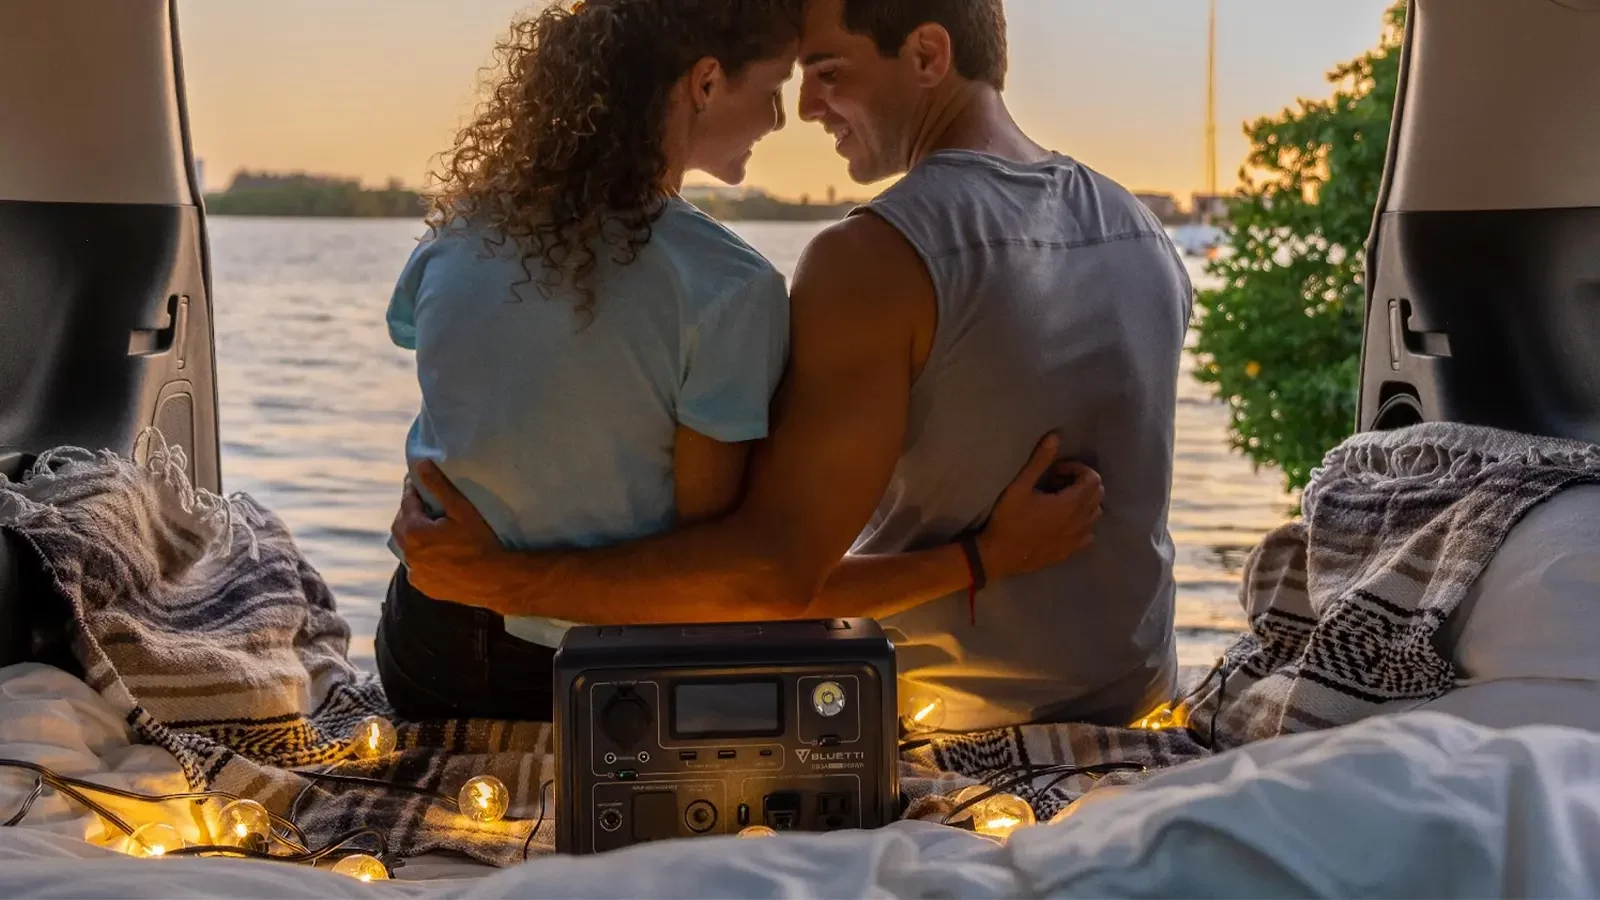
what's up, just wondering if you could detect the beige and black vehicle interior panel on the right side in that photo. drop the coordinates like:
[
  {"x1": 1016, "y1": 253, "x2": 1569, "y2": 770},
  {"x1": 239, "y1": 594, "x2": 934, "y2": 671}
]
[{"x1": 1357, "y1": 0, "x2": 1600, "y2": 442}]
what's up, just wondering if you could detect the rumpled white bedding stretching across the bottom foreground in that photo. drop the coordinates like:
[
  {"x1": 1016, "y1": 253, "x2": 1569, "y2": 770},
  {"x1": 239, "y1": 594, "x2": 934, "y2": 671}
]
[{"x1": 0, "y1": 656, "x2": 1600, "y2": 898}]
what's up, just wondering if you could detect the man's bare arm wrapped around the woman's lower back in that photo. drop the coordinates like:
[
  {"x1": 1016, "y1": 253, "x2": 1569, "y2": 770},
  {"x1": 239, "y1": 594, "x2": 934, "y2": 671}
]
[{"x1": 397, "y1": 216, "x2": 921, "y2": 625}]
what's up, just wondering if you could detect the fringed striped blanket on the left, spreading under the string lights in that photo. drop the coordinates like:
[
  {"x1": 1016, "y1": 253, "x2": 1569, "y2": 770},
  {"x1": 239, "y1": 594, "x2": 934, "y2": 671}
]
[{"x1": 0, "y1": 436, "x2": 555, "y2": 865}]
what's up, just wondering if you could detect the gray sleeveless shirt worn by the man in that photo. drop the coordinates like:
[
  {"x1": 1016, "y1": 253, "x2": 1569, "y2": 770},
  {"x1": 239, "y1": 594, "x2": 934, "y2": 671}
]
[{"x1": 853, "y1": 151, "x2": 1192, "y2": 730}]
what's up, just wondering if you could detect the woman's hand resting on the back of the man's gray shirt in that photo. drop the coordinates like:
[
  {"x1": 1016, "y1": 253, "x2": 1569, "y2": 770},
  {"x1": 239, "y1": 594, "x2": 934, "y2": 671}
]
[{"x1": 978, "y1": 434, "x2": 1106, "y2": 578}]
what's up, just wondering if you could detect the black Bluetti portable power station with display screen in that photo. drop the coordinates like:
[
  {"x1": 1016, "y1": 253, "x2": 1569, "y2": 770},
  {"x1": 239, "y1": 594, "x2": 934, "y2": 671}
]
[{"x1": 554, "y1": 618, "x2": 901, "y2": 854}]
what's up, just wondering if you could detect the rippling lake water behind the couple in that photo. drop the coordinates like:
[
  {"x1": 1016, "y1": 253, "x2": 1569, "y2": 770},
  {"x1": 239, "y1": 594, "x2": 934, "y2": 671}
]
[{"x1": 210, "y1": 218, "x2": 1291, "y2": 665}]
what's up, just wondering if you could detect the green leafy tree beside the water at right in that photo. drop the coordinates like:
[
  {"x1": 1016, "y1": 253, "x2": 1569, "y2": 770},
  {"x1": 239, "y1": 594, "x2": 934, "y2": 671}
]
[{"x1": 1194, "y1": 3, "x2": 1405, "y2": 490}]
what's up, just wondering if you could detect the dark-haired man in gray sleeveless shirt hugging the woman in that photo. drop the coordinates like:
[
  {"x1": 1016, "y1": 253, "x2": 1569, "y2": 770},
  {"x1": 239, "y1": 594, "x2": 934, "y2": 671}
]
[{"x1": 395, "y1": 0, "x2": 1192, "y2": 730}]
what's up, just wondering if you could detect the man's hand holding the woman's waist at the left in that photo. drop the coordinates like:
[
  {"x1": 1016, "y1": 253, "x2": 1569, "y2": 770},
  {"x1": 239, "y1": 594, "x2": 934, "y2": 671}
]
[{"x1": 390, "y1": 460, "x2": 504, "y2": 609}]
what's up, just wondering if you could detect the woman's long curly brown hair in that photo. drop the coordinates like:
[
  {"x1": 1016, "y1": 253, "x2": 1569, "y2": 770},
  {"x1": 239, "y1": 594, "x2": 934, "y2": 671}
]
[{"x1": 426, "y1": 0, "x2": 803, "y2": 314}]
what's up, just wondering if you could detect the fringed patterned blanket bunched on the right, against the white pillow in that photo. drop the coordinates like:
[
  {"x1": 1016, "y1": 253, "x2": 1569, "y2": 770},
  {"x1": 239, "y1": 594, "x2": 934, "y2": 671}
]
[{"x1": 1181, "y1": 423, "x2": 1600, "y2": 749}]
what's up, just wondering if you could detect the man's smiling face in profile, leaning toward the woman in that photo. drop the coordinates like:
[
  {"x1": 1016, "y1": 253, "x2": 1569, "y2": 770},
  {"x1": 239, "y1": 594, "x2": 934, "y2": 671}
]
[{"x1": 800, "y1": 0, "x2": 923, "y2": 184}]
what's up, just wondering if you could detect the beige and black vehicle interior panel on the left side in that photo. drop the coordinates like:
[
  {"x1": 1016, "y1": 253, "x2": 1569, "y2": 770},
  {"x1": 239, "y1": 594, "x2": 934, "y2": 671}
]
[{"x1": 0, "y1": 0, "x2": 221, "y2": 490}]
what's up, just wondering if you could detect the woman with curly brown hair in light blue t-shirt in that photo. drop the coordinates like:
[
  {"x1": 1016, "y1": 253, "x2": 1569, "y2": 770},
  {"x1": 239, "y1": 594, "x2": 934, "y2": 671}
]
[{"x1": 378, "y1": 0, "x2": 1100, "y2": 721}]
